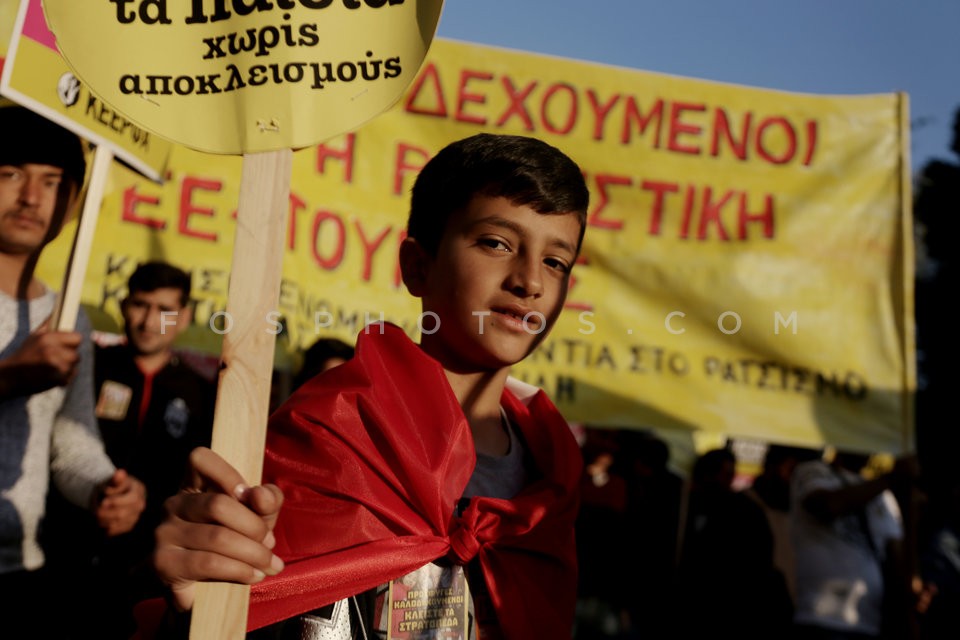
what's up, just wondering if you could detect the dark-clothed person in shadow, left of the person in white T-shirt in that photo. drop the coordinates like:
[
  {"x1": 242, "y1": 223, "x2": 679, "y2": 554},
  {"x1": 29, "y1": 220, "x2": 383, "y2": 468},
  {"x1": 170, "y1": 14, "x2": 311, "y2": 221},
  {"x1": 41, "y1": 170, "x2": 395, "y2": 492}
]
[{"x1": 674, "y1": 449, "x2": 792, "y2": 640}]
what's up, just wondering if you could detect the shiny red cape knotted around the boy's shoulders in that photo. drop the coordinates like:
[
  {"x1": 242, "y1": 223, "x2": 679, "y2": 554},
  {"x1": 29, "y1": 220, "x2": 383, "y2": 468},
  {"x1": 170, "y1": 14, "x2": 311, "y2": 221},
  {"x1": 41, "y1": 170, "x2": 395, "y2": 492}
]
[{"x1": 249, "y1": 325, "x2": 582, "y2": 640}]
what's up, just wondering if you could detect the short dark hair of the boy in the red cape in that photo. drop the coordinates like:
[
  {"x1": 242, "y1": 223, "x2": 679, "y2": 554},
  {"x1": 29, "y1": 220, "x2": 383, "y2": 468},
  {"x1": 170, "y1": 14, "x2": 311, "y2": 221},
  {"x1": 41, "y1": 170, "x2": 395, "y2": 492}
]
[{"x1": 407, "y1": 133, "x2": 590, "y2": 256}]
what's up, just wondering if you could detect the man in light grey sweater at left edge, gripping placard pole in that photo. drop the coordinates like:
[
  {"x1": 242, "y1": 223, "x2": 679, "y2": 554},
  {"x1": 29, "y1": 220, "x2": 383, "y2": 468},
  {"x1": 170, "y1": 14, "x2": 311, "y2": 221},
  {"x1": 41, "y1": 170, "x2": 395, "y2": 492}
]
[{"x1": 0, "y1": 106, "x2": 144, "y2": 638}]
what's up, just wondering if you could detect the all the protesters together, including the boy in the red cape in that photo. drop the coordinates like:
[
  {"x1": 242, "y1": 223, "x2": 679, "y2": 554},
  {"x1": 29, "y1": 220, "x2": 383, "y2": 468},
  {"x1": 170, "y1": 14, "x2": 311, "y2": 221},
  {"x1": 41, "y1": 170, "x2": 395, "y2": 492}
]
[{"x1": 0, "y1": 100, "x2": 960, "y2": 640}]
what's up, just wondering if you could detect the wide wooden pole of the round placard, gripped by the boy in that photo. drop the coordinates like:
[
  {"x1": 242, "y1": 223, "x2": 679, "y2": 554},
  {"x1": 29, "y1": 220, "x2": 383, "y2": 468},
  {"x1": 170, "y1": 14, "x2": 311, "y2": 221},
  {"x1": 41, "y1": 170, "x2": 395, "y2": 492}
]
[{"x1": 190, "y1": 149, "x2": 293, "y2": 640}]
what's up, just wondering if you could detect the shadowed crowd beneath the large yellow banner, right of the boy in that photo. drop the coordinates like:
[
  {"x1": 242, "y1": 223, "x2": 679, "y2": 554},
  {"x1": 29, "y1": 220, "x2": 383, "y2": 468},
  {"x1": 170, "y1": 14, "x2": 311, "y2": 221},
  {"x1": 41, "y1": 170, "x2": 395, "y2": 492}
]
[{"x1": 574, "y1": 429, "x2": 960, "y2": 640}]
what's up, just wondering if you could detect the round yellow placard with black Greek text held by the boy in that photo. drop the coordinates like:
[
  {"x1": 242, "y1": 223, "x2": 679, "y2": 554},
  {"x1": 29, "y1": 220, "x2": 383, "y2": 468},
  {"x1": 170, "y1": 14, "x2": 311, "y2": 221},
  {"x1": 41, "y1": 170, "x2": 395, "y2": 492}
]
[{"x1": 43, "y1": 0, "x2": 443, "y2": 154}]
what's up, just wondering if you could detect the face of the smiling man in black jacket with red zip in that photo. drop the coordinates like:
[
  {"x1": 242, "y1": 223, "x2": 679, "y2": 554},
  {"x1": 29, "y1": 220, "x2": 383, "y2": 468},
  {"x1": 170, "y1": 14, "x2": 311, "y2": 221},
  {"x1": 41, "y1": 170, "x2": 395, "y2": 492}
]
[{"x1": 120, "y1": 287, "x2": 190, "y2": 355}]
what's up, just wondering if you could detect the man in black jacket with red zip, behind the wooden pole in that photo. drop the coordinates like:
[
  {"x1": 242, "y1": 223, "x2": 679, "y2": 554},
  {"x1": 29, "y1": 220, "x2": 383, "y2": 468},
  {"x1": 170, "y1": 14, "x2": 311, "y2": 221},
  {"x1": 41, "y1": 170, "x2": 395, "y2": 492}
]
[{"x1": 45, "y1": 261, "x2": 216, "y2": 640}]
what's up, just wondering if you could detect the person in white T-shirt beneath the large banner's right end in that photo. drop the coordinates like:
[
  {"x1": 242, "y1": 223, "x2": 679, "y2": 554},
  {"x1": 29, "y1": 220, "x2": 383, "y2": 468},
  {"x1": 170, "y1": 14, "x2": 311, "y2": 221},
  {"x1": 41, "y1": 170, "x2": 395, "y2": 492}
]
[{"x1": 791, "y1": 451, "x2": 919, "y2": 640}]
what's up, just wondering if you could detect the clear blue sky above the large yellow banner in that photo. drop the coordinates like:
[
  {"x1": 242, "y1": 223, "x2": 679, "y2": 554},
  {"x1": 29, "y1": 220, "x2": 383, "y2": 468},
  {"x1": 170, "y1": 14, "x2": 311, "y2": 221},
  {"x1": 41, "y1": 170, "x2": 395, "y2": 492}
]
[{"x1": 437, "y1": 0, "x2": 960, "y2": 176}]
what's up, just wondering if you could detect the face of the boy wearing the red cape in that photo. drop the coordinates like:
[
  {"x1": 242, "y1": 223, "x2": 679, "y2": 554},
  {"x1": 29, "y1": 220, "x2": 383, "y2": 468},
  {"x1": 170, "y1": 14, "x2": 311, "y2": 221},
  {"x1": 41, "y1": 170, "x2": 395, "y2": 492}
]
[{"x1": 404, "y1": 196, "x2": 580, "y2": 373}]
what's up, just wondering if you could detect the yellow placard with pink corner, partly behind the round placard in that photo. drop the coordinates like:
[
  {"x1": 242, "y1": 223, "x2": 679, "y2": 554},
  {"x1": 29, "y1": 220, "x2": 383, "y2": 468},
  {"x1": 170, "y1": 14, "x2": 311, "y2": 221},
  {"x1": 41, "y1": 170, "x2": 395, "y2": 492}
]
[{"x1": 0, "y1": 0, "x2": 171, "y2": 181}]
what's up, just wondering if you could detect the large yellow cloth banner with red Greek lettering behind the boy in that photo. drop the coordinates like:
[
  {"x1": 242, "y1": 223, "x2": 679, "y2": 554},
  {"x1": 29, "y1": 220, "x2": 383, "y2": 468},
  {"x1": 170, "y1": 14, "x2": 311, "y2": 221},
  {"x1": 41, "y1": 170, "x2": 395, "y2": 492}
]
[{"x1": 33, "y1": 40, "x2": 915, "y2": 451}]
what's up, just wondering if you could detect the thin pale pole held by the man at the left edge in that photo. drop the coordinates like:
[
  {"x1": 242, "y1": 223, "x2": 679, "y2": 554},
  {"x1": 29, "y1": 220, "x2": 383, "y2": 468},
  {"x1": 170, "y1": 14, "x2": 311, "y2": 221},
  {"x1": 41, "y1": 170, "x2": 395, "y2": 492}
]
[{"x1": 50, "y1": 144, "x2": 113, "y2": 331}]
